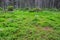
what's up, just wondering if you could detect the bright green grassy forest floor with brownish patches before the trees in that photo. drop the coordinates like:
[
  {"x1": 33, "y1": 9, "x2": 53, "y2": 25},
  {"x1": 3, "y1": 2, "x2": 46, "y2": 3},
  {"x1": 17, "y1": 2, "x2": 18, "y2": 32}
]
[{"x1": 0, "y1": 10, "x2": 60, "y2": 40}]
